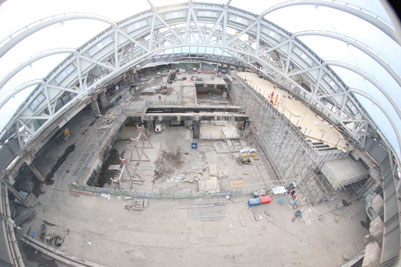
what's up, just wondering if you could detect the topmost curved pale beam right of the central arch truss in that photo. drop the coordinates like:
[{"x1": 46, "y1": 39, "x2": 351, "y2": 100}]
[{"x1": 259, "y1": 0, "x2": 401, "y2": 45}]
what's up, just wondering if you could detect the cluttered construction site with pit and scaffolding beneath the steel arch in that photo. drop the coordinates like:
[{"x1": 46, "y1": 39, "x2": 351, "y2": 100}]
[{"x1": 0, "y1": 69, "x2": 382, "y2": 266}]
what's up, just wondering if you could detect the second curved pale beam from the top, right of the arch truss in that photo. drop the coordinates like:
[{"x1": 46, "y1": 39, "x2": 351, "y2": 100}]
[{"x1": 292, "y1": 31, "x2": 401, "y2": 86}]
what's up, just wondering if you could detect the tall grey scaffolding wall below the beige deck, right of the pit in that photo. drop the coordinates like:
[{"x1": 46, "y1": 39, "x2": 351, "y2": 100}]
[{"x1": 230, "y1": 74, "x2": 348, "y2": 204}]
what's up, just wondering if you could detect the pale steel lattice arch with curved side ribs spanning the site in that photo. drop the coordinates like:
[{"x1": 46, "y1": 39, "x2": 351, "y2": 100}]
[{"x1": 0, "y1": 1, "x2": 401, "y2": 159}]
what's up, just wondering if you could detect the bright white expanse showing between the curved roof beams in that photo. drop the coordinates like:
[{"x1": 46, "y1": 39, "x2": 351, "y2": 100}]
[{"x1": 0, "y1": 0, "x2": 401, "y2": 156}]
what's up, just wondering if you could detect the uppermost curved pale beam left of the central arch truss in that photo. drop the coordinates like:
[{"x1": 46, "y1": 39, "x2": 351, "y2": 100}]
[{"x1": 0, "y1": 13, "x2": 117, "y2": 58}]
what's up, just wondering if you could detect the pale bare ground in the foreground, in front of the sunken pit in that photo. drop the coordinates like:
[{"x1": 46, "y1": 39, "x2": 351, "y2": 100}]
[{"x1": 21, "y1": 191, "x2": 367, "y2": 266}]
